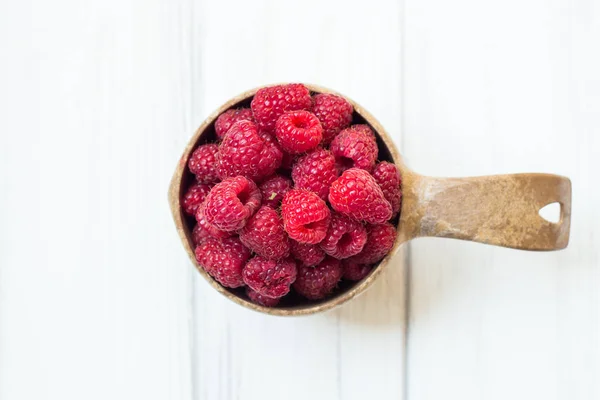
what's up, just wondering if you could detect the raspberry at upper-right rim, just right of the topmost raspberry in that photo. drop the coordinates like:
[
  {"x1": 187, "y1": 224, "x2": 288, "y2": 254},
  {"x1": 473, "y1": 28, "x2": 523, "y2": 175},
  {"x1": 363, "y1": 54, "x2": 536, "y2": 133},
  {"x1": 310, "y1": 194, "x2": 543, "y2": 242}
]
[{"x1": 312, "y1": 93, "x2": 354, "y2": 144}]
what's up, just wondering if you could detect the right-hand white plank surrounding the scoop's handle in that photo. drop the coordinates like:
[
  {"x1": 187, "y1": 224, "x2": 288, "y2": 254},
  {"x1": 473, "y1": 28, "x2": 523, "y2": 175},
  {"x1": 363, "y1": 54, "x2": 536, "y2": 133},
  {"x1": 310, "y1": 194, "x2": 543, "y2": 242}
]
[{"x1": 402, "y1": 0, "x2": 600, "y2": 400}]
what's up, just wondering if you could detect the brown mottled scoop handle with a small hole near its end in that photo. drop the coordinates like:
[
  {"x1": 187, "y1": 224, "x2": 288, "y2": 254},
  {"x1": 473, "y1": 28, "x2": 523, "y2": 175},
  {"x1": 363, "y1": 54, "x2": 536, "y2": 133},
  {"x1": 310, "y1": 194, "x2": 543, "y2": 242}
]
[{"x1": 411, "y1": 174, "x2": 571, "y2": 250}]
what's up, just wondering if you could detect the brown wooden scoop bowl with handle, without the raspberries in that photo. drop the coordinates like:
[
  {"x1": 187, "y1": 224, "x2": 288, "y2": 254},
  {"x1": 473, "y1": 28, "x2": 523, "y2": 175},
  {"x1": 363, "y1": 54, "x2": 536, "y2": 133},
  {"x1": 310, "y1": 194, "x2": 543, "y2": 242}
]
[{"x1": 169, "y1": 84, "x2": 571, "y2": 316}]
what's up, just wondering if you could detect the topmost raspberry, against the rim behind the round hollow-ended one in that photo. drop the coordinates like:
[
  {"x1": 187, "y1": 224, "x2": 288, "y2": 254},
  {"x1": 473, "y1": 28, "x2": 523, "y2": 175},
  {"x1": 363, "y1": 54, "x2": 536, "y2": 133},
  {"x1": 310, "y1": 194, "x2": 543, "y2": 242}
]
[{"x1": 250, "y1": 83, "x2": 312, "y2": 132}]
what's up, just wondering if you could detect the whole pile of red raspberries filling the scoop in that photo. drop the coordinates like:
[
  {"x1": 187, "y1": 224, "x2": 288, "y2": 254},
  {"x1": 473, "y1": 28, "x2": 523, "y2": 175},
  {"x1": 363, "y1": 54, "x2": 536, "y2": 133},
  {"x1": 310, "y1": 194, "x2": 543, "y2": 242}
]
[{"x1": 181, "y1": 84, "x2": 401, "y2": 307}]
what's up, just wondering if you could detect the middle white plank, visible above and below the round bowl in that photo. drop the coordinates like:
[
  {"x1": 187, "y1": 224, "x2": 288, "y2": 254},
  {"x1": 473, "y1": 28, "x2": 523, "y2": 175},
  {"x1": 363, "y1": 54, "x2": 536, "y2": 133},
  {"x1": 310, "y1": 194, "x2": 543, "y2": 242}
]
[{"x1": 193, "y1": 0, "x2": 404, "y2": 400}]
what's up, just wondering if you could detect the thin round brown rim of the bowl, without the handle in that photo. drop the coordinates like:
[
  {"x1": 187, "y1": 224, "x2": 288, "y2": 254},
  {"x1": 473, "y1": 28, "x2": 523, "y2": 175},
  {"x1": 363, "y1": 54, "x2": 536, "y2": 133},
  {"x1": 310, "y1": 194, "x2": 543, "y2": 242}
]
[{"x1": 169, "y1": 83, "x2": 404, "y2": 316}]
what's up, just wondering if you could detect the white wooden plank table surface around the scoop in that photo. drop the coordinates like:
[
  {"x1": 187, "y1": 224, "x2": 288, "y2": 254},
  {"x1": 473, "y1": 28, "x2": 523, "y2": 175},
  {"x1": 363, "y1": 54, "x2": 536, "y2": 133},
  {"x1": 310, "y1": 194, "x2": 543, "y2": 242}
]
[{"x1": 0, "y1": 0, "x2": 600, "y2": 400}]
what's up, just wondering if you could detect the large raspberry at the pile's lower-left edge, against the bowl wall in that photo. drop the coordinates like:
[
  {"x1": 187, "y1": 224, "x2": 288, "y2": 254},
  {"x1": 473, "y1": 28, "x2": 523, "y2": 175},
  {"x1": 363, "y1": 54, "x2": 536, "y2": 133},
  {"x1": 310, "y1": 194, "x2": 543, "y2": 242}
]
[{"x1": 195, "y1": 237, "x2": 250, "y2": 288}]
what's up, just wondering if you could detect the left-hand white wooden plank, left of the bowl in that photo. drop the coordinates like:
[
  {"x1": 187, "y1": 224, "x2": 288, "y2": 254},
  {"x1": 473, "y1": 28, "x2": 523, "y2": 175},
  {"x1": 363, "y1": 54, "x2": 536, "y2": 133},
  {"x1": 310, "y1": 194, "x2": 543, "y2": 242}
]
[{"x1": 0, "y1": 0, "x2": 192, "y2": 400}]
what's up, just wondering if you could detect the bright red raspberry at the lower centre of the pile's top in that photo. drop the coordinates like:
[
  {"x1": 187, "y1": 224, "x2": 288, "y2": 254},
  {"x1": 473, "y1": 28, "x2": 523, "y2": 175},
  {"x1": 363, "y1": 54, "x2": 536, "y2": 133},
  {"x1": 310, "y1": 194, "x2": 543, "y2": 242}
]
[{"x1": 281, "y1": 189, "x2": 330, "y2": 244}]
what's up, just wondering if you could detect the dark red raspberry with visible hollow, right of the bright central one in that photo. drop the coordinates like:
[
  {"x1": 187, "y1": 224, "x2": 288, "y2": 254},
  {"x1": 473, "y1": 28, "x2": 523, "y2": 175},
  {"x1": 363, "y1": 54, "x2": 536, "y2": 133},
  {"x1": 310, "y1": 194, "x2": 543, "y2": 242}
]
[{"x1": 319, "y1": 212, "x2": 367, "y2": 260}]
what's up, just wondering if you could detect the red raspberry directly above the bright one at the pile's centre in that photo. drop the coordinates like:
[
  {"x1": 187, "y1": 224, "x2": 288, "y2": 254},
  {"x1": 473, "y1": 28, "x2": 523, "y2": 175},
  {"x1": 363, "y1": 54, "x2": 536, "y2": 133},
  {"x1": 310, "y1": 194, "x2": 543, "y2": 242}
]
[{"x1": 292, "y1": 149, "x2": 337, "y2": 200}]
